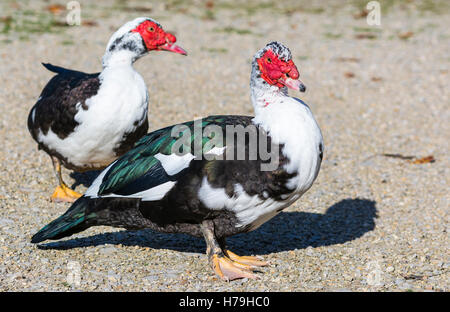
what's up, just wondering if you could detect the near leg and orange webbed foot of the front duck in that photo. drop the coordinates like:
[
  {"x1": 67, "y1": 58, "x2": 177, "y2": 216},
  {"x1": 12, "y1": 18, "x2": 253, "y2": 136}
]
[{"x1": 200, "y1": 220, "x2": 257, "y2": 281}]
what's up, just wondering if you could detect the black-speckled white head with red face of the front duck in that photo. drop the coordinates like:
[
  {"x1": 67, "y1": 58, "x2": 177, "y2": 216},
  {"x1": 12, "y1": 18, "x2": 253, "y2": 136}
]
[{"x1": 251, "y1": 41, "x2": 306, "y2": 92}]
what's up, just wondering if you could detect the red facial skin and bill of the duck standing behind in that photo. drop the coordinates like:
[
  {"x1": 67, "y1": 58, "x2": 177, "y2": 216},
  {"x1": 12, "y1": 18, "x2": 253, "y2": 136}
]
[{"x1": 132, "y1": 21, "x2": 187, "y2": 55}]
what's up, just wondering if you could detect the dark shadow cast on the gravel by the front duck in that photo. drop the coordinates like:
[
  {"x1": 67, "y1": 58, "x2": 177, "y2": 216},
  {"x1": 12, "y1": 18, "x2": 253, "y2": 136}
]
[{"x1": 39, "y1": 198, "x2": 377, "y2": 255}]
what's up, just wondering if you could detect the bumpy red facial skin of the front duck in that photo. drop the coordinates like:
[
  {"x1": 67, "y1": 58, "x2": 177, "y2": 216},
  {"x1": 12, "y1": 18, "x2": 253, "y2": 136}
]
[{"x1": 257, "y1": 50, "x2": 299, "y2": 88}]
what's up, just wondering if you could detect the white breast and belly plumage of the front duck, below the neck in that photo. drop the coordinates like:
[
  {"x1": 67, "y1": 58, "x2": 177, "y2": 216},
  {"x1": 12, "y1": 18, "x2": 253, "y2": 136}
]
[{"x1": 198, "y1": 97, "x2": 322, "y2": 230}]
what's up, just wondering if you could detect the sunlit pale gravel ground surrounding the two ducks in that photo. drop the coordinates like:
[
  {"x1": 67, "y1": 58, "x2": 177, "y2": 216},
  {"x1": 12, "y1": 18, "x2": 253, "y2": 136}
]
[{"x1": 0, "y1": 1, "x2": 450, "y2": 291}]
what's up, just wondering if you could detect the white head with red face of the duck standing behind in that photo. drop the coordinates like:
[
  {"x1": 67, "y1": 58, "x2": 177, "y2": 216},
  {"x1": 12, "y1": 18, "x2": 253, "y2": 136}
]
[{"x1": 103, "y1": 17, "x2": 187, "y2": 66}]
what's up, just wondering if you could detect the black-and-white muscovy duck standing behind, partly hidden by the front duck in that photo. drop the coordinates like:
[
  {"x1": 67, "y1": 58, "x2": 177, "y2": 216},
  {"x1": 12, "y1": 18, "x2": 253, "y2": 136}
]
[{"x1": 28, "y1": 17, "x2": 186, "y2": 202}]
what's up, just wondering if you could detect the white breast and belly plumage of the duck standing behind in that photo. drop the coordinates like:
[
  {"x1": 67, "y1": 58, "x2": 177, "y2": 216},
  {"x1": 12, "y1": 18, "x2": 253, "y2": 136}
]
[{"x1": 38, "y1": 66, "x2": 148, "y2": 167}]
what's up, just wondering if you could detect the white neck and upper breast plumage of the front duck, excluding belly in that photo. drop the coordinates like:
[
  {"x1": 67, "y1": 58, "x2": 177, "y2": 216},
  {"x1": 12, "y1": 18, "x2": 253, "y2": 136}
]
[{"x1": 251, "y1": 73, "x2": 322, "y2": 192}]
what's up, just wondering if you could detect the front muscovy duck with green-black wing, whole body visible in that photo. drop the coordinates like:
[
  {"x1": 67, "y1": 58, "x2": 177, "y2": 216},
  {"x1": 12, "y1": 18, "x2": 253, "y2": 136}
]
[{"x1": 31, "y1": 42, "x2": 323, "y2": 280}]
